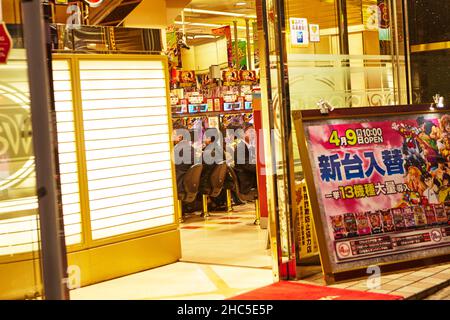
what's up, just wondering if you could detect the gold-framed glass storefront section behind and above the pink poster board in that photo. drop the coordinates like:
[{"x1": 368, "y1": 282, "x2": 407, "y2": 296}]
[{"x1": 258, "y1": 0, "x2": 448, "y2": 279}]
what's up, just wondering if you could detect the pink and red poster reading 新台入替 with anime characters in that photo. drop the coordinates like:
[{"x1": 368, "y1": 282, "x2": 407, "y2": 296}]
[{"x1": 305, "y1": 114, "x2": 450, "y2": 271}]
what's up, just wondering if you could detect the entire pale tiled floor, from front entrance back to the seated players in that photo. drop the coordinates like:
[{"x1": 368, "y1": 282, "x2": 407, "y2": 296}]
[{"x1": 70, "y1": 203, "x2": 273, "y2": 300}]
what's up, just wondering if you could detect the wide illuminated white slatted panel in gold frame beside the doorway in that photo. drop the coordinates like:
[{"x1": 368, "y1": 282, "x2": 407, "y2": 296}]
[{"x1": 80, "y1": 60, "x2": 175, "y2": 240}]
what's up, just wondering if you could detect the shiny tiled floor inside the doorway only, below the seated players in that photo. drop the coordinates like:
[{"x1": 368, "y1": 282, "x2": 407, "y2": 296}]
[{"x1": 180, "y1": 203, "x2": 272, "y2": 269}]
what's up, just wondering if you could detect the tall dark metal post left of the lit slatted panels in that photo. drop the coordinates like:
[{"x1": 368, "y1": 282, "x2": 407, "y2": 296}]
[{"x1": 22, "y1": 0, "x2": 67, "y2": 300}]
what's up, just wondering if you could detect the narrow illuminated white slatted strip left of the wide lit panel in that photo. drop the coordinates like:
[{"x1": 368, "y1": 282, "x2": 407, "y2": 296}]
[{"x1": 53, "y1": 60, "x2": 82, "y2": 245}]
